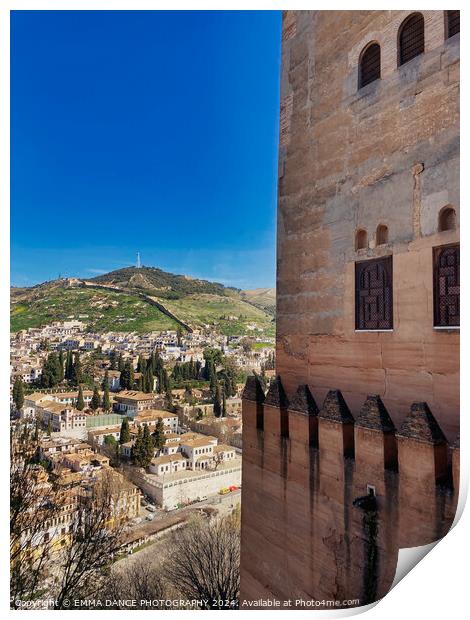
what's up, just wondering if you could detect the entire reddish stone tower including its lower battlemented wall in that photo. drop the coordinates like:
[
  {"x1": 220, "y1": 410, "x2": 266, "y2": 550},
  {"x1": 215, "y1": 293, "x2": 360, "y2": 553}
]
[{"x1": 241, "y1": 11, "x2": 460, "y2": 608}]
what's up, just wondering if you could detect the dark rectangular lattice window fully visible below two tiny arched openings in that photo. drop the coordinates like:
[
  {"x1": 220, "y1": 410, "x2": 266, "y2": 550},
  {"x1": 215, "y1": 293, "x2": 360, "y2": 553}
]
[{"x1": 356, "y1": 256, "x2": 393, "y2": 330}]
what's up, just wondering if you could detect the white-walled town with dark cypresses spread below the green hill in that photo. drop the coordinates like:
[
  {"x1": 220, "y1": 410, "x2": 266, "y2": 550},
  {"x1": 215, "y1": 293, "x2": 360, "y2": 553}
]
[{"x1": 10, "y1": 320, "x2": 274, "y2": 592}]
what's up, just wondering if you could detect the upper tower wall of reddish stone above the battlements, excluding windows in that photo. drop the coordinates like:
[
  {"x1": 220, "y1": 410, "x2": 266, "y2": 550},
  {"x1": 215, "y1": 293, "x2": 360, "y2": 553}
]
[{"x1": 277, "y1": 11, "x2": 459, "y2": 441}]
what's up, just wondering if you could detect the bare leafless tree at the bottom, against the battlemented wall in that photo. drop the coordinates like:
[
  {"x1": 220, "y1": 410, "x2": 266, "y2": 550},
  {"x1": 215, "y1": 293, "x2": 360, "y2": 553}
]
[{"x1": 165, "y1": 516, "x2": 240, "y2": 609}]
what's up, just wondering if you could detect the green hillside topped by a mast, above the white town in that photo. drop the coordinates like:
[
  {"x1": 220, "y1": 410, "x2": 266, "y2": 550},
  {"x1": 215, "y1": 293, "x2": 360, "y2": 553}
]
[{"x1": 10, "y1": 267, "x2": 274, "y2": 337}]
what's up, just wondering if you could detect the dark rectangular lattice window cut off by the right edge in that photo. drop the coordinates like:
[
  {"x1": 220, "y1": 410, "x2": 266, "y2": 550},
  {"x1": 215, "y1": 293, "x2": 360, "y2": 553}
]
[{"x1": 434, "y1": 245, "x2": 460, "y2": 327}]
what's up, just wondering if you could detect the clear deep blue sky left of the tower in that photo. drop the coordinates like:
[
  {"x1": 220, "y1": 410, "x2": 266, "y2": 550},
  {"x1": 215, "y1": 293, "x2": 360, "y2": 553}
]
[{"x1": 11, "y1": 11, "x2": 281, "y2": 288}]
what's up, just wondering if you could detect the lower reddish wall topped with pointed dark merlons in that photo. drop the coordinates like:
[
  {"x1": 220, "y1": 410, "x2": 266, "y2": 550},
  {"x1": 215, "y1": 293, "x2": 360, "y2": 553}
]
[{"x1": 241, "y1": 377, "x2": 459, "y2": 604}]
